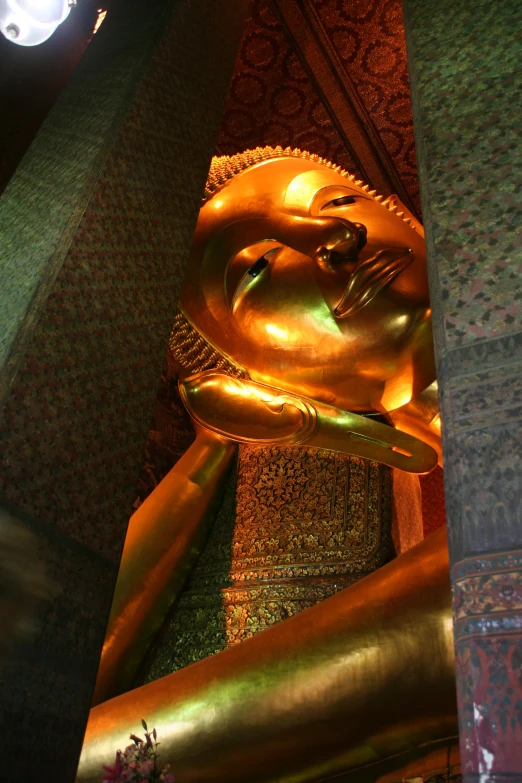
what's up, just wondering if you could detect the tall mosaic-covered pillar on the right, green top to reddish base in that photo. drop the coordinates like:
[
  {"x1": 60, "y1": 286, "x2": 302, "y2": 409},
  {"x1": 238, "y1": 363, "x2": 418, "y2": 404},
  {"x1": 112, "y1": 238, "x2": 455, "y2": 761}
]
[{"x1": 404, "y1": 0, "x2": 522, "y2": 783}]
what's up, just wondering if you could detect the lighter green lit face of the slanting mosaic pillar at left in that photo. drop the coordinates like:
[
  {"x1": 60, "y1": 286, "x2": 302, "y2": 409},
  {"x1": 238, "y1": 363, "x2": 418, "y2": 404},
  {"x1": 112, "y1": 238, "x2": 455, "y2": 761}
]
[{"x1": 0, "y1": 2, "x2": 165, "y2": 400}]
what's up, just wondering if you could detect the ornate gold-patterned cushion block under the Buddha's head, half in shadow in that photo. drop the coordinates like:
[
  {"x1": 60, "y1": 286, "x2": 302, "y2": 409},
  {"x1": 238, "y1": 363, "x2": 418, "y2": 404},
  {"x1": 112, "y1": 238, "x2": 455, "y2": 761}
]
[{"x1": 139, "y1": 445, "x2": 392, "y2": 684}]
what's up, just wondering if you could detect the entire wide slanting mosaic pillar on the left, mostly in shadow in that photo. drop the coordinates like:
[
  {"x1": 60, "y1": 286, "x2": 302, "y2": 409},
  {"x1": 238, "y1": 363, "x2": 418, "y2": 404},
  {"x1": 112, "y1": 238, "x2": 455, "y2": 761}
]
[{"x1": 0, "y1": 0, "x2": 245, "y2": 783}]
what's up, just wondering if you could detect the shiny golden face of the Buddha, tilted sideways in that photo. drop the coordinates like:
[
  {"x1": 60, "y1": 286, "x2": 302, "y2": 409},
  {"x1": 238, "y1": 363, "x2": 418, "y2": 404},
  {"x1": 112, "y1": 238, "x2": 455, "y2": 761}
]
[{"x1": 181, "y1": 152, "x2": 435, "y2": 412}]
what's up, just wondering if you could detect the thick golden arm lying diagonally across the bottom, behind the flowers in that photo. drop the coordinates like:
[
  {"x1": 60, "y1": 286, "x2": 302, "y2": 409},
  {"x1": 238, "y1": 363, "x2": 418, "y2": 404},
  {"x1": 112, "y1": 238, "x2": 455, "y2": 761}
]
[{"x1": 77, "y1": 530, "x2": 457, "y2": 783}]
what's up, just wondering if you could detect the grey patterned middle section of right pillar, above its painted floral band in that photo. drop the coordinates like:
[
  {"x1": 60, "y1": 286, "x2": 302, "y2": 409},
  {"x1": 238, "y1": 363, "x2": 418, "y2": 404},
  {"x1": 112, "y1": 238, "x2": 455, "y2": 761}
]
[{"x1": 440, "y1": 344, "x2": 522, "y2": 559}]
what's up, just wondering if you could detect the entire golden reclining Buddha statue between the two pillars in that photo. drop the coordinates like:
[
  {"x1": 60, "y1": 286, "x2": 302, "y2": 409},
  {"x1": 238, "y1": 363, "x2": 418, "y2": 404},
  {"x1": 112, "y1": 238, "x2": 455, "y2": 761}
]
[{"x1": 77, "y1": 147, "x2": 457, "y2": 783}]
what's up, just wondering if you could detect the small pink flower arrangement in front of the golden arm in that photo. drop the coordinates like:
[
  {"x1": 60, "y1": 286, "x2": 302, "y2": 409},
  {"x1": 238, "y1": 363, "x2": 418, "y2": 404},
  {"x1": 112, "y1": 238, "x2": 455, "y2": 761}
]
[{"x1": 102, "y1": 720, "x2": 174, "y2": 783}]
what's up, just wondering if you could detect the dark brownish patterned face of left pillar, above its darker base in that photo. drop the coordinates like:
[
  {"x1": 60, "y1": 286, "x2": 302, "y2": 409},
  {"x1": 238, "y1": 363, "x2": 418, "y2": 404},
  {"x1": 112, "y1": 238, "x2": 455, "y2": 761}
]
[{"x1": 0, "y1": 3, "x2": 245, "y2": 562}]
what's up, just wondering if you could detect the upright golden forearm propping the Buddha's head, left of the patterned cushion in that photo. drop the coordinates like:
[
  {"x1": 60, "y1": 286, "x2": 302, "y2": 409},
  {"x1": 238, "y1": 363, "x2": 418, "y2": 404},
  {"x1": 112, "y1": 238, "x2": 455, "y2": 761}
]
[{"x1": 93, "y1": 429, "x2": 236, "y2": 704}]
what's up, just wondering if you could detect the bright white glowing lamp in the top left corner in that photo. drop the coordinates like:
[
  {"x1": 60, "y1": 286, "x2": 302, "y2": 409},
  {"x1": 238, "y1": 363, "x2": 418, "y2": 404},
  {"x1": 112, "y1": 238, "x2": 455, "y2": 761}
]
[{"x1": 0, "y1": 0, "x2": 76, "y2": 46}]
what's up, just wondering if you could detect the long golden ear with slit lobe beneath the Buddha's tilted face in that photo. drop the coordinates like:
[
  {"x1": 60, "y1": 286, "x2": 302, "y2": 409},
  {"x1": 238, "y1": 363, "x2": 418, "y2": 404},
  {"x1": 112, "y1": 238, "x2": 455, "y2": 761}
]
[{"x1": 180, "y1": 370, "x2": 437, "y2": 473}]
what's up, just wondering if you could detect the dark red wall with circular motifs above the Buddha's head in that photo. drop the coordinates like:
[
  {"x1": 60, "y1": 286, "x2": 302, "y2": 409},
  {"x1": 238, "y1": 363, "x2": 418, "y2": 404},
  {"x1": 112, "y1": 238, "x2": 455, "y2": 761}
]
[{"x1": 213, "y1": 0, "x2": 420, "y2": 211}]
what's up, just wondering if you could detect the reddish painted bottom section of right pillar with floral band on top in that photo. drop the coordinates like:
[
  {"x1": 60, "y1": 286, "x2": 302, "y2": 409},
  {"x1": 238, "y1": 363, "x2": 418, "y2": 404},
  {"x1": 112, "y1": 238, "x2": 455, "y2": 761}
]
[{"x1": 452, "y1": 550, "x2": 522, "y2": 783}]
